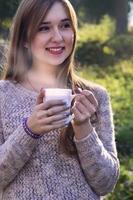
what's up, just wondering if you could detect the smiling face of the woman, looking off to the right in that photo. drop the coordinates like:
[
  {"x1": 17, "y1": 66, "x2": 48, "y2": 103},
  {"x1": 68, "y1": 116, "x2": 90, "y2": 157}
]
[{"x1": 31, "y1": 2, "x2": 74, "y2": 67}]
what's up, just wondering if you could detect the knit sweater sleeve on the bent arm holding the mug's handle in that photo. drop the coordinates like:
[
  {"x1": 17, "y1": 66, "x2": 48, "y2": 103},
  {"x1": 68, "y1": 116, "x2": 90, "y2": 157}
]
[{"x1": 75, "y1": 90, "x2": 119, "y2": 196}]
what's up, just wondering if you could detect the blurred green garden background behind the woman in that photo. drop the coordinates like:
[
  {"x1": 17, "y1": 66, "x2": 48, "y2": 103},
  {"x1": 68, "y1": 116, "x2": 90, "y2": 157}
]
[{"x1": 0, "y1": 0, "x2": 133, "y2": 200}]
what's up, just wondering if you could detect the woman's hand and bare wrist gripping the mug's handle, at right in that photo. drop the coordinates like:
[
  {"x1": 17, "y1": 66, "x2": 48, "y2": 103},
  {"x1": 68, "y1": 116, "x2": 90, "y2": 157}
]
[{"x1": 71, "y1": 90, "x2": 98, "y2": 139}]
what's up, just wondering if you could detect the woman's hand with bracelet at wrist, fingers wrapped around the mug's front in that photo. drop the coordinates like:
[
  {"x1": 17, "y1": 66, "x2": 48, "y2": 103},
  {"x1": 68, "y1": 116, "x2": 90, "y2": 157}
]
[{"x1": 27, "y1": 90, "x2": 70, "y2": 134}]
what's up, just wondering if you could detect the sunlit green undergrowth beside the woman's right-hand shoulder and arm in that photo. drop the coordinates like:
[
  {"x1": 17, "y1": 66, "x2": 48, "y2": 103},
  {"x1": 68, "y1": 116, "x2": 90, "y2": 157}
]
[{"x1": 78, "y1": 63, "x2": 133, "y2": 200}]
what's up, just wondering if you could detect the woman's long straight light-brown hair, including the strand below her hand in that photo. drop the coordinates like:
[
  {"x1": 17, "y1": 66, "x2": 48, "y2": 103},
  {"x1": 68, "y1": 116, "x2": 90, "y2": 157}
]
[{"x1": 3, "y1": 0, "x2": 92, "y2": 153}]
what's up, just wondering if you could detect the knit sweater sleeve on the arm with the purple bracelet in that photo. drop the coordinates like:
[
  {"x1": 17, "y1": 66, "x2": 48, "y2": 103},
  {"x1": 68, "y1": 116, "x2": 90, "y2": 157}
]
[{"x1": 0, "y1": 102, "x2": 37, "y2": 191}]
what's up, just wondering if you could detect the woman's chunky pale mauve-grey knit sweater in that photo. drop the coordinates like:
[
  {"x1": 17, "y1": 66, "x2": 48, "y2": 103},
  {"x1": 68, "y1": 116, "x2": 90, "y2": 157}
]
[{"x1": 0, "y1": 80, "x2": 119, "y2": 200}]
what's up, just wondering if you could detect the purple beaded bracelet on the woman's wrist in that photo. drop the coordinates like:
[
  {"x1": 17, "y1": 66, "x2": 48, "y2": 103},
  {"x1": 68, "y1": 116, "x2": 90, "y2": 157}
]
[{"x1": 23, "y1": 117, "x2": 42, "y2": 139}]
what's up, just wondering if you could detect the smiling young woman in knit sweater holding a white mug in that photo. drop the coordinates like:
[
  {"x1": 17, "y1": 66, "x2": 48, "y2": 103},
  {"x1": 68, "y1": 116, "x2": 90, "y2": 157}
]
[{"x1": 0, "y1": 0, "x2": 119, "y2": 200}]
